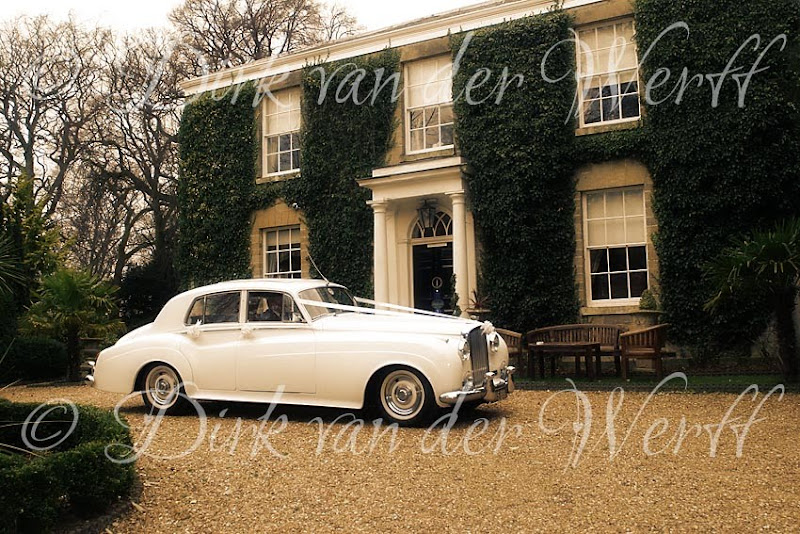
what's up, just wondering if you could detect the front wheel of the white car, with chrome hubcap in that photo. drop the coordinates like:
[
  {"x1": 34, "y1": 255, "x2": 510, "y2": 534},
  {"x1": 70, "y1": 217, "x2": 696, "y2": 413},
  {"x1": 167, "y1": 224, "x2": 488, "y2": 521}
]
[{"x1": 376, "y1": 368, "x2": 434, "y2": 426}]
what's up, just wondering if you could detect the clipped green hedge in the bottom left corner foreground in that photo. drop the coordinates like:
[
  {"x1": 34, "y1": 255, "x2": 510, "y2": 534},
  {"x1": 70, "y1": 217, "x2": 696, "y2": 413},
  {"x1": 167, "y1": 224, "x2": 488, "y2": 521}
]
[{"x1": 0, "y1": 400, "x2": 134, "y2": 533}]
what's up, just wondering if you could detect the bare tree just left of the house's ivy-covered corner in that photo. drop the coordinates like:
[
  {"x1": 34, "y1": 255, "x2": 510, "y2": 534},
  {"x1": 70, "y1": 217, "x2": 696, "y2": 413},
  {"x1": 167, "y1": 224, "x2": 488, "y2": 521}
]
[{"x1": 84, "y1": 31, "x2": 181, "y2": 279}]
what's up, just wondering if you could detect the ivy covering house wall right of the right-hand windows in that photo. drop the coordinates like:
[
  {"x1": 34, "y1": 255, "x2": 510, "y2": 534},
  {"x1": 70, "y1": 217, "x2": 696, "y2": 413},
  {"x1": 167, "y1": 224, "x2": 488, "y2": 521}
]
[{"x1": 636, "y1": 0, "x2": 800, "y2": 345}]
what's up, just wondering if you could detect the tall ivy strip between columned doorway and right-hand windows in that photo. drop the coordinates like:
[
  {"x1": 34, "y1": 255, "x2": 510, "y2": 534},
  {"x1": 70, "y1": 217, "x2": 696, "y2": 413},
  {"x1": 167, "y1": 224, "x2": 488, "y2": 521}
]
[{"x1": 451, "y1": 12, "x2": 578, "y2": 331}]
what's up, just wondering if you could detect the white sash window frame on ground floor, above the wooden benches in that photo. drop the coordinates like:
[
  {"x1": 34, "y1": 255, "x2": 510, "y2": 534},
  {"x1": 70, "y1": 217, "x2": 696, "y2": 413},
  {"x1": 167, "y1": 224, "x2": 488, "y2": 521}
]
[{"x1": 581, "y1": 185, "x2": 650, "y2": 308}]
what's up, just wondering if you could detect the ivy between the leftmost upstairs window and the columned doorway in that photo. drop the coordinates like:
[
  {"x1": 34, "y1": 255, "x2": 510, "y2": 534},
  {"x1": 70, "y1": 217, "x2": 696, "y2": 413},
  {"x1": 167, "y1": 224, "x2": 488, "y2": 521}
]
[{"x1": 286, "y1": 50, "x2": 400, "y2": 295}]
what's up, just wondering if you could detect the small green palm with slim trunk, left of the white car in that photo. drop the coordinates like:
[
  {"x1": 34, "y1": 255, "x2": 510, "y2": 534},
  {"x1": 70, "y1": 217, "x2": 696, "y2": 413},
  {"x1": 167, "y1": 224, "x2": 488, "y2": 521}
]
[{"x1": 22, "y1": 269, "x2": 124, "y2": 381}]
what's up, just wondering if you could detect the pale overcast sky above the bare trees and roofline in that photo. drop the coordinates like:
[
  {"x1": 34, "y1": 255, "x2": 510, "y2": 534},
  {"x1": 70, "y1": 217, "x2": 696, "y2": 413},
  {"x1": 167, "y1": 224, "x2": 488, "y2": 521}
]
[{"x1": 6, "y1": 0, "x2": 483, "y2": 30}]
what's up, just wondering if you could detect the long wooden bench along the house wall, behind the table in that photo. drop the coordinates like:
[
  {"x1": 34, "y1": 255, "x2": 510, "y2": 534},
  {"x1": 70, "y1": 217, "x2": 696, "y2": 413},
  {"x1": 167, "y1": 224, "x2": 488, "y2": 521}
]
[{"x1": 526, "y1": 324, "x2": 625, "y2": 378}]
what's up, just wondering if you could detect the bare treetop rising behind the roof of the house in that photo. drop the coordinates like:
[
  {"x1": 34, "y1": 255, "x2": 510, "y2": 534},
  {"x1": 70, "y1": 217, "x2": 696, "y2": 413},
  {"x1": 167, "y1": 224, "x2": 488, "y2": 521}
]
[{"x1": 170, "y1": 0, "x2": 357, "y2": 75}]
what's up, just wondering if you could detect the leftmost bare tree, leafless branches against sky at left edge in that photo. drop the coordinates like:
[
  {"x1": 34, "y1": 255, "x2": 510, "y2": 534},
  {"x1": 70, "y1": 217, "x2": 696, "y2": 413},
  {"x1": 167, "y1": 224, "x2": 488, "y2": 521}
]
[{"x1": 0, "y1": 16, "x2": 111, "y2": 217}]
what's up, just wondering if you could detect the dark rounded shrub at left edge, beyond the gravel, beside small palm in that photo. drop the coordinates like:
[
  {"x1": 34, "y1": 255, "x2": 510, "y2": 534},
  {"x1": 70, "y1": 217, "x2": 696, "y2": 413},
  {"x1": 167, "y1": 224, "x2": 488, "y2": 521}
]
[{"x1": 0, "y1": 337, "x2": 67, "y2": 386}]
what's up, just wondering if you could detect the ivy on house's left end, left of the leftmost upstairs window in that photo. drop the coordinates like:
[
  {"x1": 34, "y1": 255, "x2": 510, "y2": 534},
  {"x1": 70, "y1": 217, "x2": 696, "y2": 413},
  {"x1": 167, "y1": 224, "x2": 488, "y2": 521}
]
[{"x1": 177, "y1": 84, "x2": 258, "y2": 287}]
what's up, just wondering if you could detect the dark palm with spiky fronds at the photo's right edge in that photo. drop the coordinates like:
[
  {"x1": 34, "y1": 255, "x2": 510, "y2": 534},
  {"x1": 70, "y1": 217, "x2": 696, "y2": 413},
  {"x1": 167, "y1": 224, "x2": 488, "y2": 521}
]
[{"x1": 706, "y1": 218, "x2": 800, "y2": 382}]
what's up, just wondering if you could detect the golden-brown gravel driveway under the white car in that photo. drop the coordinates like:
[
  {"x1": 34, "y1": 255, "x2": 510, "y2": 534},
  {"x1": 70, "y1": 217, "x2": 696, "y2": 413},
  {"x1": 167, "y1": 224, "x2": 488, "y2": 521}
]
[{"x1": 0, "y1": 387, "x2": 800, "y2": 533}]
